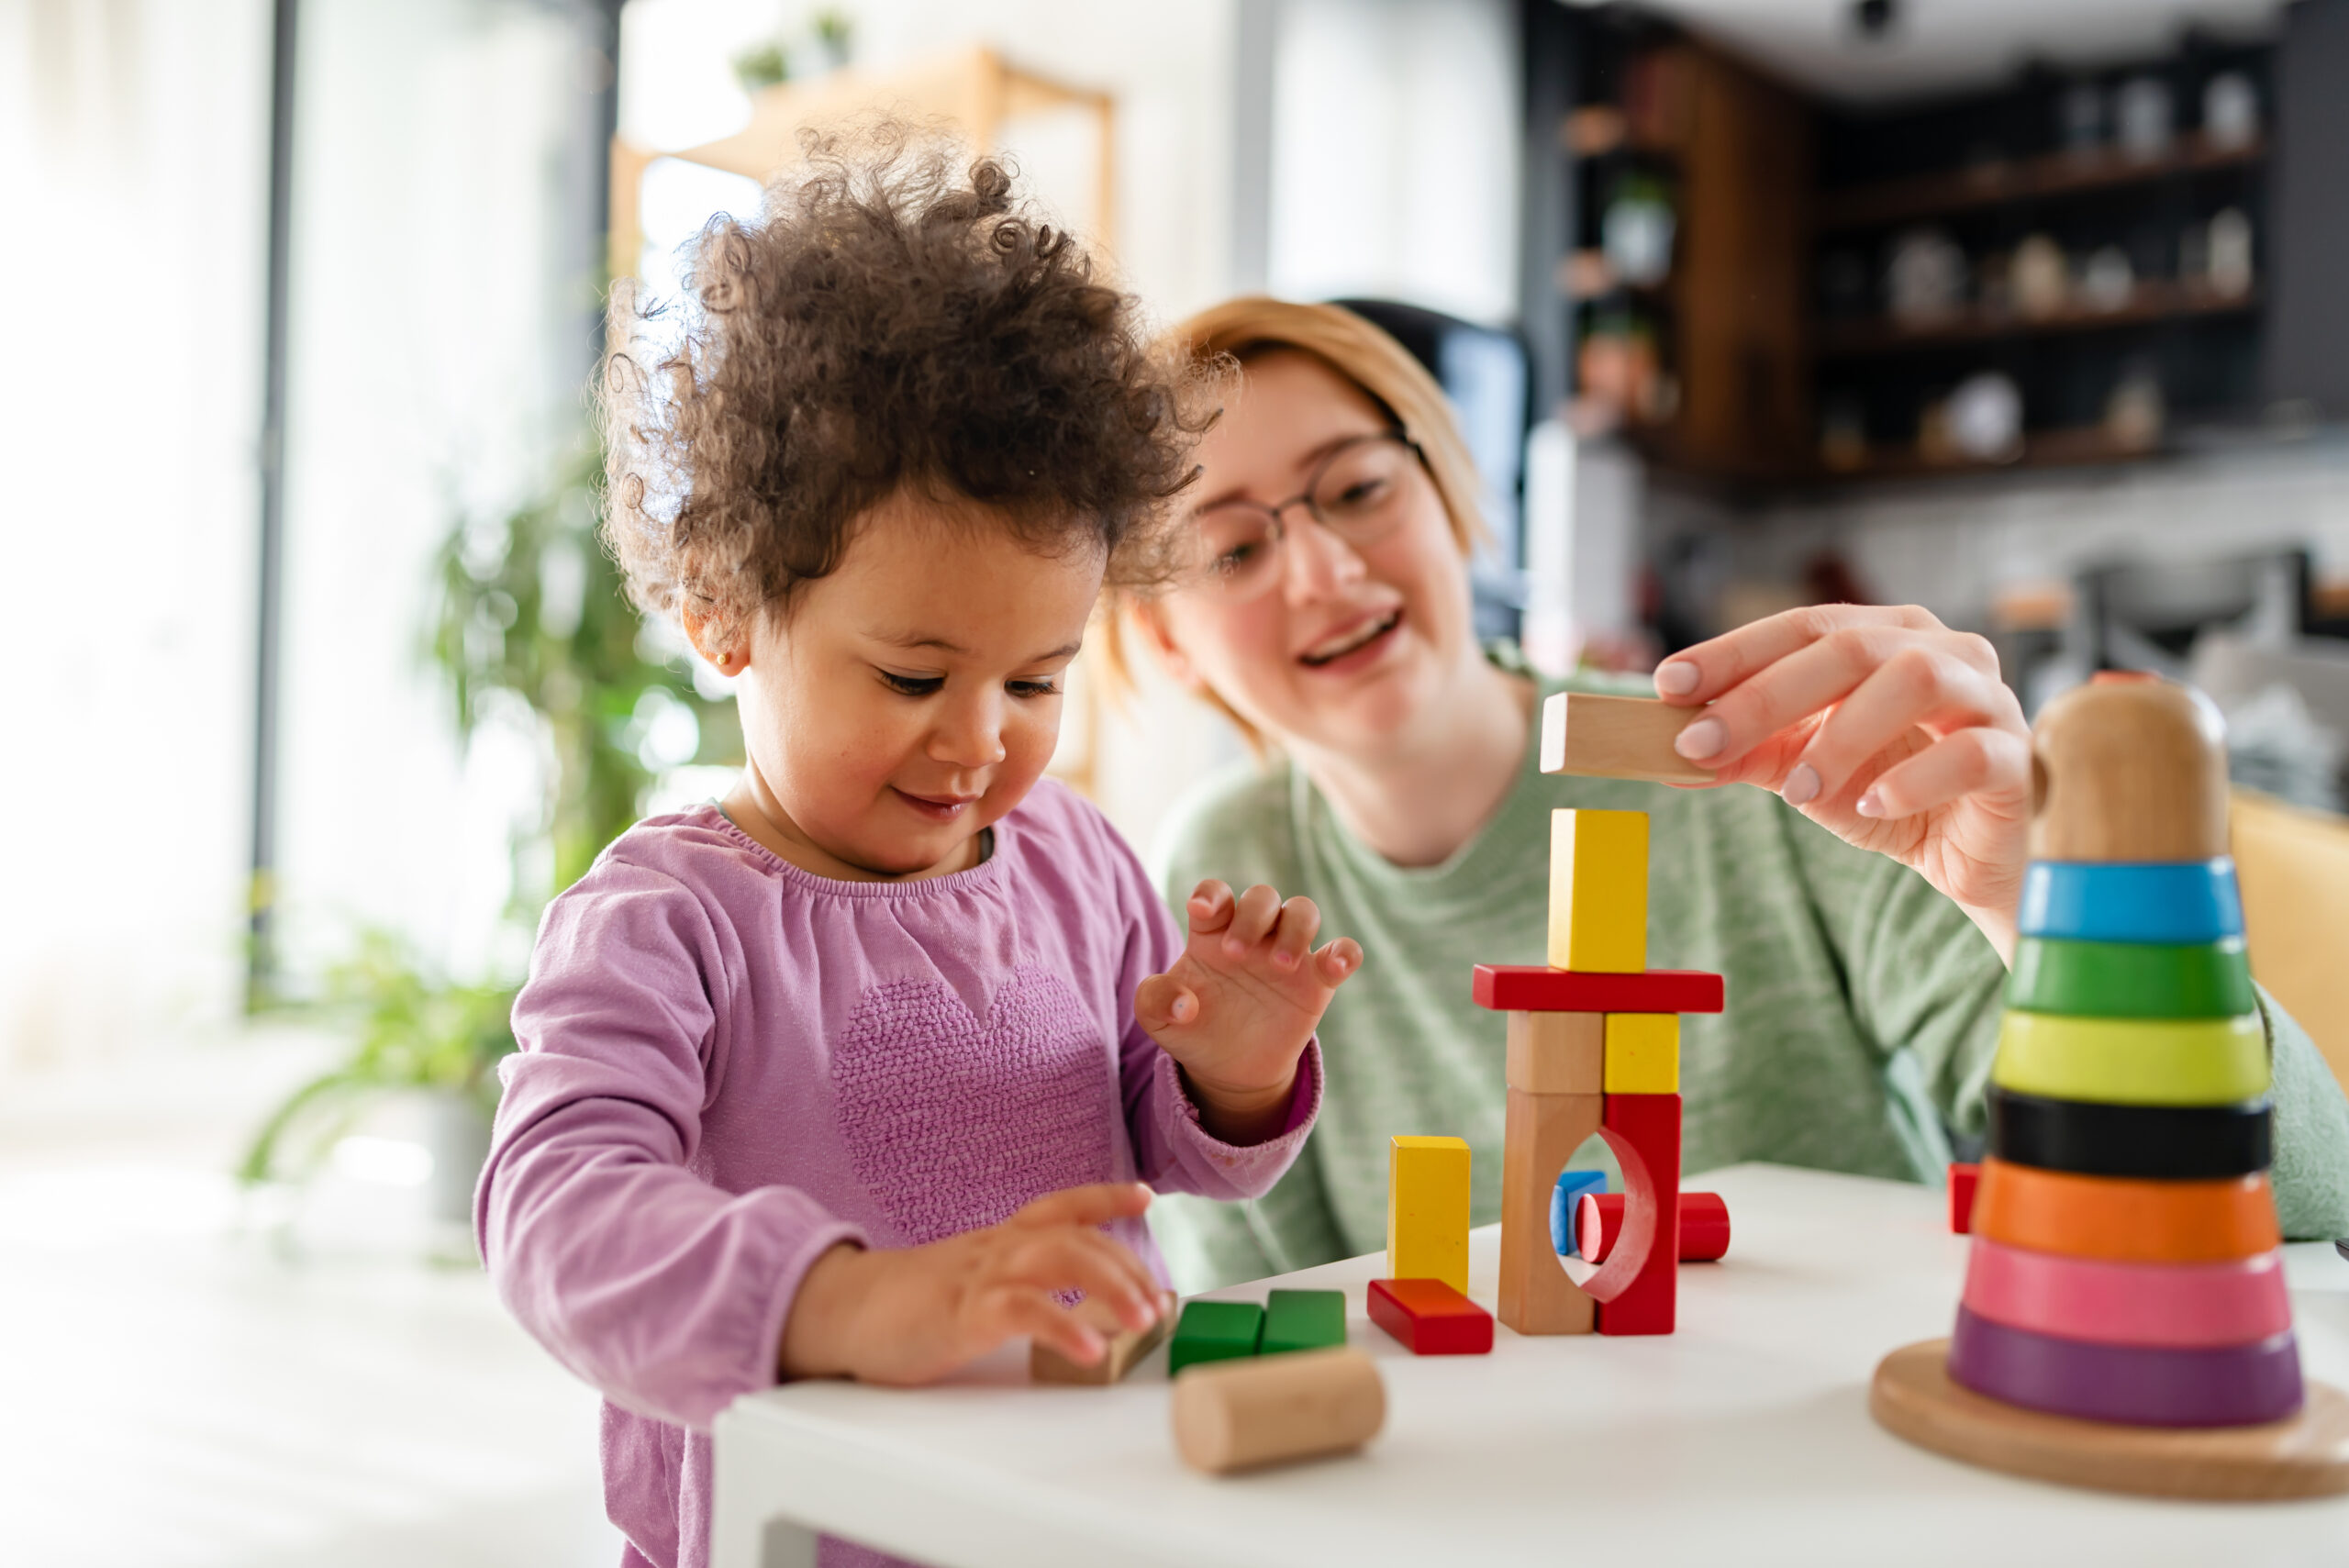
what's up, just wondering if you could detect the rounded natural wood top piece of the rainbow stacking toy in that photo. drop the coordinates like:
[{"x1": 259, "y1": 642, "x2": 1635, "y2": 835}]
[{"x1": 2030, "y1": 676, "x2": 2227, "y2": 862}]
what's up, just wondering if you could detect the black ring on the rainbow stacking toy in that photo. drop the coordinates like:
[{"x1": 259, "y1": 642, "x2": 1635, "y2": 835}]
[{"x1": 1989, "y1": 1084, "x2": 2277, "y2": 1181}]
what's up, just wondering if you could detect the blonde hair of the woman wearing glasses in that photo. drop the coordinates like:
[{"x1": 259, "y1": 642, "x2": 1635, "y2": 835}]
[{"x1": 1102, "y1": 294, "x2": 1486, "y2": 753}]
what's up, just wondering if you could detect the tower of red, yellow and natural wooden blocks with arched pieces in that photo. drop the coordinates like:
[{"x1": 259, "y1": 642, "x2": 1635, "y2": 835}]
[{"x1": 1475, "y1": 693, "x2": 1721, "y2": 1333}]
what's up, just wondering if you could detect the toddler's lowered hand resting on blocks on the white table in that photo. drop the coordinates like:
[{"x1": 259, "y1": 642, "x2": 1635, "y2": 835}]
[{"x1": 777, "y1": 1181, "x2": 1172, "y2": 1385}]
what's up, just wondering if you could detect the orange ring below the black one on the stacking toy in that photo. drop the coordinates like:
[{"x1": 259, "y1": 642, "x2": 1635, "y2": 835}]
[{"x1": 1973, "y1": 1160, "x2": 2283, "y2": 1262}]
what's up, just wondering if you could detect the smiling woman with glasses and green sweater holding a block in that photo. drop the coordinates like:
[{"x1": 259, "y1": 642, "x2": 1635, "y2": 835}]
[{"x1": 1123, "y1": 298, "x2": 2349, "y2": 1289}]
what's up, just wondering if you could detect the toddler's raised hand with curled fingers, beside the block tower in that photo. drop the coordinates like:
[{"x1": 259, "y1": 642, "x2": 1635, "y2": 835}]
[{"x1": 1134, "y1": 878, "x2": 1363, "y2": 1143}]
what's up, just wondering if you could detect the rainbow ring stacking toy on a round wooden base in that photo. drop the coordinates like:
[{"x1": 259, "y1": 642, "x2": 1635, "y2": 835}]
[{"x1": 1870, "y1": 673, "x2": 2349, "y2": 1496}]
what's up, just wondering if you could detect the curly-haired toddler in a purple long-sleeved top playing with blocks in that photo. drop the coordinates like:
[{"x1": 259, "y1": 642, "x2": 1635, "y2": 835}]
[{"x1": 477, "y1": 131, "x2": 1360, "y2": 1568}]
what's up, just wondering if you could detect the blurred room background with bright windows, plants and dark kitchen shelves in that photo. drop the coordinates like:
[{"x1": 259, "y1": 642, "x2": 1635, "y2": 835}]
[{"x1": 0, "y1": 0, "x2": 2349, "y2": 1568}]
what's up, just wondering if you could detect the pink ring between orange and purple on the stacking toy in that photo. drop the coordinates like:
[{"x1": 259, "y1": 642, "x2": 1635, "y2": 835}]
[{"x1": 1966, "y1": 1237, "x2": 2293, "y2": 1350}]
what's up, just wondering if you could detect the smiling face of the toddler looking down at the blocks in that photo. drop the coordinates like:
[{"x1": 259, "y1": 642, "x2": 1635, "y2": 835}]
[{"x1": 729, "y1": 491, "x2": 1102, "y2": 878}]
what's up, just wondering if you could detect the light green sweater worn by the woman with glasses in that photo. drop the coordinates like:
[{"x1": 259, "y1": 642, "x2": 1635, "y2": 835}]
[{"x1": 1151, "y1": 662, "x2": 2349, "y2": 1291}]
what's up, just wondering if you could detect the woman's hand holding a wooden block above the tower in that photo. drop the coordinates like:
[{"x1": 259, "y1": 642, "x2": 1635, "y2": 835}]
[{"x1": 1656, "y1": 604, "x2": 2032, "y2": 962}]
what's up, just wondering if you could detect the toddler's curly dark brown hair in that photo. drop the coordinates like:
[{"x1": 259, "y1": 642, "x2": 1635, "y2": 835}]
[{"x1": 601, "y1": 119, "x2": 1219, "y2": 640}]
